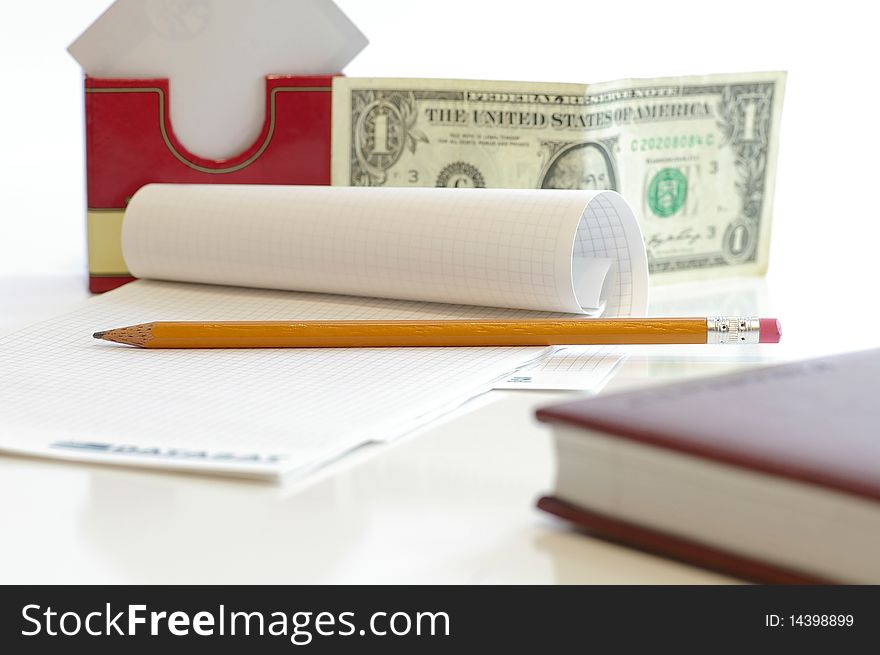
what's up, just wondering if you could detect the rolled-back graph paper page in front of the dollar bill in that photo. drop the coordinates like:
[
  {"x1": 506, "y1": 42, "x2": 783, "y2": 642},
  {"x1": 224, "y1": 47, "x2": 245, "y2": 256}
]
[{"x1": 122, "y1": 184, "x2": 648, "y2": 316}]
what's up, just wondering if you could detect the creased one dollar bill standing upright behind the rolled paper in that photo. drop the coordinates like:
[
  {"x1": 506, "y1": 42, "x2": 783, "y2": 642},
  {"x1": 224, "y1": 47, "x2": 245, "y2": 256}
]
[{"x1": 333, "y1": 72, "x2": 785, "y2": 281}]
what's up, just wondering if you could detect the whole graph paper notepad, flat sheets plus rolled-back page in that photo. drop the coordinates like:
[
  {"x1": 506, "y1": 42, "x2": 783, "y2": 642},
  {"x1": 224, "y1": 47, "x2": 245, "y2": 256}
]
[{"x1": 0, "y1": 185, "x2": 647, "y2": 478}]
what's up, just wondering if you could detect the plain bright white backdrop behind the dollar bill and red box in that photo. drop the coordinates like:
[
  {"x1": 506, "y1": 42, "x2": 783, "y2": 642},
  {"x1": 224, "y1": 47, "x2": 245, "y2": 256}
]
[{"x1": 0, "y1": 0, "x2": 880, "y2": 346}]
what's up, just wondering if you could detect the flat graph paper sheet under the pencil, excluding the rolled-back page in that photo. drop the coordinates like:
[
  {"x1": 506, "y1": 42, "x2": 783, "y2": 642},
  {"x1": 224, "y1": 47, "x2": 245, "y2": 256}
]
[{"x1": 0, "y1": 280, "x2": 572, "y2": 477}]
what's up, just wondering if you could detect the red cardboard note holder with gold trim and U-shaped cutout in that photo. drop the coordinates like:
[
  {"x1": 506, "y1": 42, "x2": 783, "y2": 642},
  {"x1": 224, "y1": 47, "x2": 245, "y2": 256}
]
[{"x1": 85, "y1": 75, "x2": 333, "y2": 292}]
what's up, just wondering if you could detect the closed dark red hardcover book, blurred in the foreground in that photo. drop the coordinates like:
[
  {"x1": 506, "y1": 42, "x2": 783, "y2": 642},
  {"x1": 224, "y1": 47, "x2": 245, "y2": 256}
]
[{"x1": 538, "y1": 350, "x2": 880, "y2": 584}]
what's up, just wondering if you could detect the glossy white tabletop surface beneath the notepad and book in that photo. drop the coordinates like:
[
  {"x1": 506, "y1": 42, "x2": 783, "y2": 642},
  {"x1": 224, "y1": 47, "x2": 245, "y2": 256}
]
[{"x1": 0, "y1": 264, "x2": 876, "y2": 584}]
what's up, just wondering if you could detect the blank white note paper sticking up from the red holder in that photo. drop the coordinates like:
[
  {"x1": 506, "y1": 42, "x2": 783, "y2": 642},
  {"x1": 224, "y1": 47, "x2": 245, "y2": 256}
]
[{"x1": 68, "y1": 0, "x2": 367, "y2": 159}]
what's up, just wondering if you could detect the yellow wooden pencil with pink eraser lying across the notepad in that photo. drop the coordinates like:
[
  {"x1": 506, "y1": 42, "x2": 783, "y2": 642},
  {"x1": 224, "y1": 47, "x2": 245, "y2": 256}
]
[{"x1": 93, "y1": 317, "x2": 780, "y2": 348}]
